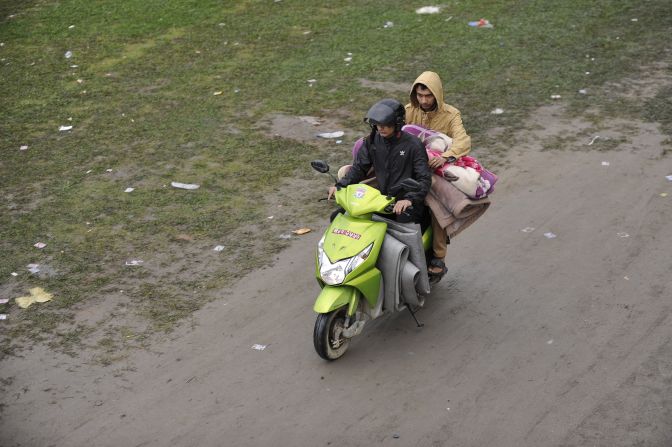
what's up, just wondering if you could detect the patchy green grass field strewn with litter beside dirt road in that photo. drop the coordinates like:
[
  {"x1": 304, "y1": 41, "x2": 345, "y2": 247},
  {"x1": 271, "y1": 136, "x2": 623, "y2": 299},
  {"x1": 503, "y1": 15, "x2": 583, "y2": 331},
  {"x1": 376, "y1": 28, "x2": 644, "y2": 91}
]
[{"x1": 0, "y1": 0, "x2": 672, "y2": 353}]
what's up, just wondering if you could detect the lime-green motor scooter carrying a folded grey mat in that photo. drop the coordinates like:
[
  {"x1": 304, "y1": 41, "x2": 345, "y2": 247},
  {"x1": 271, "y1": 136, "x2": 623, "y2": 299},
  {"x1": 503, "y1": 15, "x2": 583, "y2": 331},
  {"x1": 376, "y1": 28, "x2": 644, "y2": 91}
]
[{"x1": 311, "y1": 160, "x2": 432, "y2": 360}]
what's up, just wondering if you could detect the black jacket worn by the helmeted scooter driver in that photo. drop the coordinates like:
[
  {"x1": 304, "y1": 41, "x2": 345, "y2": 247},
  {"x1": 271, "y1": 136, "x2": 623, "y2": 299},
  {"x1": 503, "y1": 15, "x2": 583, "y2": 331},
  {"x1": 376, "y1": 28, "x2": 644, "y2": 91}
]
[{"x1": 336, "y1": 132, "x2": 432, "y2": 206}]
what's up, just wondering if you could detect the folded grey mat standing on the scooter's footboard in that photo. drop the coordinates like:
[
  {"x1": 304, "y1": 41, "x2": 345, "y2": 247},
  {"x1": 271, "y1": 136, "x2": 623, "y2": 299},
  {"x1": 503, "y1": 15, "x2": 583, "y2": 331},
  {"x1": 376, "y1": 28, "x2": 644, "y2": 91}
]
[{"x1": 373, "y1": 214, "x2": 430, "y2": 310}]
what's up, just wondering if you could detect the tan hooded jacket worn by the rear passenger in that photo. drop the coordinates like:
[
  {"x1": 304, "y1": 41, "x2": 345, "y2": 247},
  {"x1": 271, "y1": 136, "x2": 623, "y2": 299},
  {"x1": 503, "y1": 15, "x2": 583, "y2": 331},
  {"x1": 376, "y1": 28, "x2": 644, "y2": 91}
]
[{"x1": 406, "y1": 71, "x2": 471, "y2": 158}]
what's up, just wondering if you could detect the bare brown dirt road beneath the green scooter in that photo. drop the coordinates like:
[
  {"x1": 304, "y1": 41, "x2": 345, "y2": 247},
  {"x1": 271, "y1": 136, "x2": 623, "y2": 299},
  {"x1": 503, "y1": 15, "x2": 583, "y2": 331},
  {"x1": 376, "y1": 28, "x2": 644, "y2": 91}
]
[{"x1": 0, "y1": 107, "x2": 672, "y2": 447}]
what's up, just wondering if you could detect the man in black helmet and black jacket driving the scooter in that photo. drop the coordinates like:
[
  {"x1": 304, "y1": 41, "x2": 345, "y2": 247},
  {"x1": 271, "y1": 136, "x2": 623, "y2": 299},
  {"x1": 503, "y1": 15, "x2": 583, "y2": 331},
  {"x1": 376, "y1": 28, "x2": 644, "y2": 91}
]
[{"x1": 328, "y1": 99, "x2": 432, "y2": 223}]
